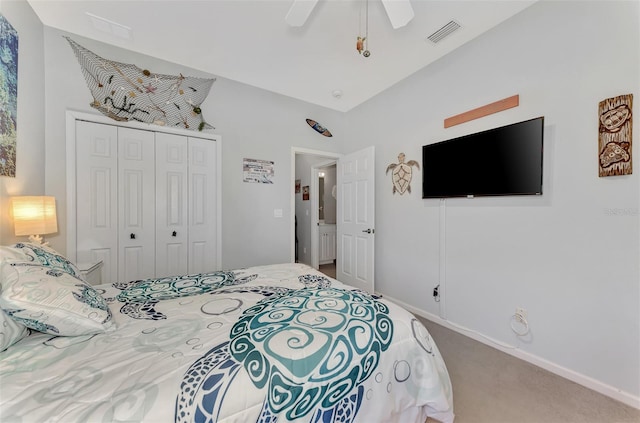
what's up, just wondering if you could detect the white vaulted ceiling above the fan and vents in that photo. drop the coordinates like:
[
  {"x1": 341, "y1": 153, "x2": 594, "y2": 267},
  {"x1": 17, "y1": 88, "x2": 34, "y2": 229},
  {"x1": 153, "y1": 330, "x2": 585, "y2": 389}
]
[{"x1": 28, "y1": 0, "x2": 535, "y2": 112}]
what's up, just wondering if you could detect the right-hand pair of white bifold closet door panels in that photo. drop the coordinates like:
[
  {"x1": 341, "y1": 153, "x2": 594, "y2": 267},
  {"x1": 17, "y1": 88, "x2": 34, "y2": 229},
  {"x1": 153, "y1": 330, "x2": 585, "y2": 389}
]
[{"x1": 156, "y1": 133, "x2": 217, "y2": 276}]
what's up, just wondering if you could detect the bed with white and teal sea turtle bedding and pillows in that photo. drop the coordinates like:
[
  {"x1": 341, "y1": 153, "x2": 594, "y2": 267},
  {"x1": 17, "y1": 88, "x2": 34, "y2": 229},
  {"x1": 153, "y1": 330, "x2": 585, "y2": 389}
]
[{"x1": 0, "y1": 243, "x2": 454, "y2": 423}]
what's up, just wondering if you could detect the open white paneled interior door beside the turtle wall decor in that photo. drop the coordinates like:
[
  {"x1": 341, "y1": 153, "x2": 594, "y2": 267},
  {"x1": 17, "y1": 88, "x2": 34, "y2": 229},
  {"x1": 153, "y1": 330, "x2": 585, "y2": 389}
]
[{"x1": 336, "y1": 146, "x2": 375, "y2": 293}]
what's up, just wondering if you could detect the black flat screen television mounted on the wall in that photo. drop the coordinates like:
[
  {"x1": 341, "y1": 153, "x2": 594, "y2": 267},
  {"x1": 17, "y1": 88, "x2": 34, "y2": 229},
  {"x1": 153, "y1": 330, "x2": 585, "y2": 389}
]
[{"x1": 422, "y1": 117, "x2": 544, "y2": 198}]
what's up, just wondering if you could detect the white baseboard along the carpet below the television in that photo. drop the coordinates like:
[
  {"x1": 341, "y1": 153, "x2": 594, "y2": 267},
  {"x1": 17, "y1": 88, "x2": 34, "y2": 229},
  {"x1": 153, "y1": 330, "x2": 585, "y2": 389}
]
[{"x1": 384, "y1": 295, "x2": 640, "y2": 409}]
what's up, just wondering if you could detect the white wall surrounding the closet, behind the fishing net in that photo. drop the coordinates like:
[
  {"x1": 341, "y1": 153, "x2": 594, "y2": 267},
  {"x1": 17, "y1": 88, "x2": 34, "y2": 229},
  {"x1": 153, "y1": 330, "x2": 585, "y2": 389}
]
[{"x1": 44, "y1": 27, "x2": 344, "y2": 268}]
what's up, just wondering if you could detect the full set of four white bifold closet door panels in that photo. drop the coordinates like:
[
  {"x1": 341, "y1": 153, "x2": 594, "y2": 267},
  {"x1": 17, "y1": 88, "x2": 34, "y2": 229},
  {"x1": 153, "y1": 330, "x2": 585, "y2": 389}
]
[{"x1": 75, "y1": 120, "x2": 219, "y2": 283}]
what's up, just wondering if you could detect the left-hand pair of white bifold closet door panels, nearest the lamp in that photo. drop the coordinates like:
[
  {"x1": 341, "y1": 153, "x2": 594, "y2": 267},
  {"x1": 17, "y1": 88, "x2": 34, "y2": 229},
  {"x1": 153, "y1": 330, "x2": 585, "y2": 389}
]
[{"x1": 76, "y1": 121, "x2": 156, "y2": 282}]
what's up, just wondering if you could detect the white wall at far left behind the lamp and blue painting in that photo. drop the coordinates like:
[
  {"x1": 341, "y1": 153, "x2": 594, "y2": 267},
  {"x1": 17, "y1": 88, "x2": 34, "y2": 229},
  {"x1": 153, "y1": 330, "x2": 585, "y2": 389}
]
[{"x1": 0, "y1": 0, "x2": 44, "y2": 245}]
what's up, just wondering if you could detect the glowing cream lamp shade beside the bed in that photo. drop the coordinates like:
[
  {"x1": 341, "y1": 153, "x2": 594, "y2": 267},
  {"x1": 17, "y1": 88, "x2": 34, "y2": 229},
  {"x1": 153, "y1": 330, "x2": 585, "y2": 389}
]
[{"x1": 11, "y1": 196, "x2": 58, "y2": 236}]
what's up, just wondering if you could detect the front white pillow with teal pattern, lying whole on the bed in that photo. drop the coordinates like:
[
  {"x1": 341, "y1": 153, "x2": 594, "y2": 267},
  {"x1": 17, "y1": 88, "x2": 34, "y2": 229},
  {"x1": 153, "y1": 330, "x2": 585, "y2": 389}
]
[{"x1": 0, "y1": 260, "x2": 113, "y2": 336}]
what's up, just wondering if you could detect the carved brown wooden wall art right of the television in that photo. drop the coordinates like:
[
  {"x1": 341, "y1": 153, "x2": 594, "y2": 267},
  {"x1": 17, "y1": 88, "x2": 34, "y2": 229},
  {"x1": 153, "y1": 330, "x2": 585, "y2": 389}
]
[{"x1": 598, "y1": 94, "x2": 633, "y2": 176}]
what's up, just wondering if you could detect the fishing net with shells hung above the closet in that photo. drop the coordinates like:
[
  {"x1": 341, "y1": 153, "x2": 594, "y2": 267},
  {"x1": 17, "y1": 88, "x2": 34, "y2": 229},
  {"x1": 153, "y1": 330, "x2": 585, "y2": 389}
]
[{"x1": 65, "y1": 37, "x2": 215, "y2": 131}]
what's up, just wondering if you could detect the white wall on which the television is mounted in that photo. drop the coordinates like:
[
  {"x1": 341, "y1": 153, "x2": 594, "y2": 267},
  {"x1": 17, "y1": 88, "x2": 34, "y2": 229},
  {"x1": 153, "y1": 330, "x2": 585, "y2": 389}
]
[{"x1": 347, "y1": 1, "x2": 640, "y2": 406}]
